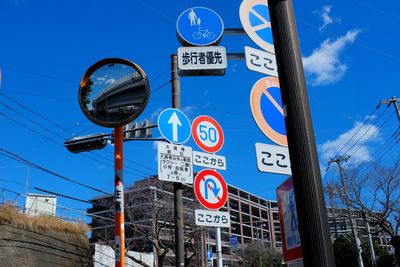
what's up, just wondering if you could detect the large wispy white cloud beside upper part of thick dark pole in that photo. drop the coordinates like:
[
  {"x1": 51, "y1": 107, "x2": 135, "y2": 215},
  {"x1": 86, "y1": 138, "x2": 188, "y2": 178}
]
[{"x1": 303, "y1": 29, "x2": 361, "y2": 85}]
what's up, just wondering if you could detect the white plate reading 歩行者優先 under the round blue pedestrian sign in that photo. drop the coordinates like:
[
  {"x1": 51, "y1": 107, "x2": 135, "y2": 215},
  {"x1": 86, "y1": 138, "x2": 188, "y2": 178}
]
[{"x1": 178, "y1": 46, "x2": 227, "y2": 70}]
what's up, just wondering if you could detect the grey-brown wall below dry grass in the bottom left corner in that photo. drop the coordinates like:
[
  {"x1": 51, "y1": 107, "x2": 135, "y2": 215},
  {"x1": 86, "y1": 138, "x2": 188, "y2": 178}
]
[{"x1": 0, "y1": 223, "x2": 93, "y2": 267}]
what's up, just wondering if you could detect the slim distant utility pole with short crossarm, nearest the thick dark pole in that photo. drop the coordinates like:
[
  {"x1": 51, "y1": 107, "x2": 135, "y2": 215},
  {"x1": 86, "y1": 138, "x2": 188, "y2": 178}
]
[{"x1": 329, "y1": 156, "x2": 364, "y2": 267}]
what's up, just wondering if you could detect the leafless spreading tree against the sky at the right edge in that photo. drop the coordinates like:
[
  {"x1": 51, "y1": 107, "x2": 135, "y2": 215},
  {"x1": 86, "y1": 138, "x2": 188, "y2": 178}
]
[{"x1": 334, "y1": 159, "x2": 400, "y2": 265}]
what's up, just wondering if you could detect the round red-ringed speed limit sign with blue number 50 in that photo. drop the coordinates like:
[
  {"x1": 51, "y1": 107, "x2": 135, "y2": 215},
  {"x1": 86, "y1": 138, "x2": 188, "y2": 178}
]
[{"x1": 192, "y1": 115, "x2": 224, "y2": 153}]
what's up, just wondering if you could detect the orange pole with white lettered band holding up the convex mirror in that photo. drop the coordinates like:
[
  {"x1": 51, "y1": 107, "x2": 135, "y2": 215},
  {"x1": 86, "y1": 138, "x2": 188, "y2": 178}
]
[{"x1": 114, "y1": 127, "x2": 125, "y2": 267}]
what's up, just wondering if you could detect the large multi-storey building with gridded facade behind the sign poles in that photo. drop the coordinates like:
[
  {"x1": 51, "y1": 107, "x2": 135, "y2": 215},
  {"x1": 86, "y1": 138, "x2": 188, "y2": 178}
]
[{"x1": 88, "y1": 176, "x2": 282, "y2": 266}]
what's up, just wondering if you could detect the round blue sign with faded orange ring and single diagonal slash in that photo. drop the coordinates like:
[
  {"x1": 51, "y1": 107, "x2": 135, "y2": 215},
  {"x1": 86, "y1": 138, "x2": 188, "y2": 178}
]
[{"x1": 250, "y1": 77, "x2": 287, "y2": 146}]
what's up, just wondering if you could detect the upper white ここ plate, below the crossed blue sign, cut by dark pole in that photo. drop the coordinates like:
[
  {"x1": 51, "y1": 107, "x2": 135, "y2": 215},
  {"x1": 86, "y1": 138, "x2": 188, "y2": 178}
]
[{"x1": 244, "y1": 46, "x2": 278, "y2": 77}]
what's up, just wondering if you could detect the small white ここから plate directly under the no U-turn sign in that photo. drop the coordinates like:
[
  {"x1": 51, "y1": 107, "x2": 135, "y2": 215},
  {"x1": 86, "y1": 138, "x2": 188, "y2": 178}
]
[{"x1": 194, "y1": 210, "x2": 231, "y2": 227}]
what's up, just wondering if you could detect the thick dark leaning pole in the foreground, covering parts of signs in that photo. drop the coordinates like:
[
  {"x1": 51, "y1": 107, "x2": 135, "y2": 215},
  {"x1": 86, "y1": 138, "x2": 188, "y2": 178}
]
[{"x1": 268, "y1": 0, "x2": 335, "y2": 267}]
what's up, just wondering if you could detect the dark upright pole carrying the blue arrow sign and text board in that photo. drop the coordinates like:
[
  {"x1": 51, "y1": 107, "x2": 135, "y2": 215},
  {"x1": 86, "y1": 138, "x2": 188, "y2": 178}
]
[{"x1": 171, "y1": 55, "x2": 185, "y2": 267}]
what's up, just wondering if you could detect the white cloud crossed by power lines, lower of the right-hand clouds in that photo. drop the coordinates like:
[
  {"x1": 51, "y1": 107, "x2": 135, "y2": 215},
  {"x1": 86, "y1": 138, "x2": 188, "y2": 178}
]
[{"x1": 319, "y1": 122, "x2": 380, "y2": 165}]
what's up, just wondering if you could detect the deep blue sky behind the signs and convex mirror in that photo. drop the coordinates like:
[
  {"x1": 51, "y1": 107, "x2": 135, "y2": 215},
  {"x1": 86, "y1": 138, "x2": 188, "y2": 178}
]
[{"x1": 0, "y1": 0, "x2": 400, "y2": 218}]
